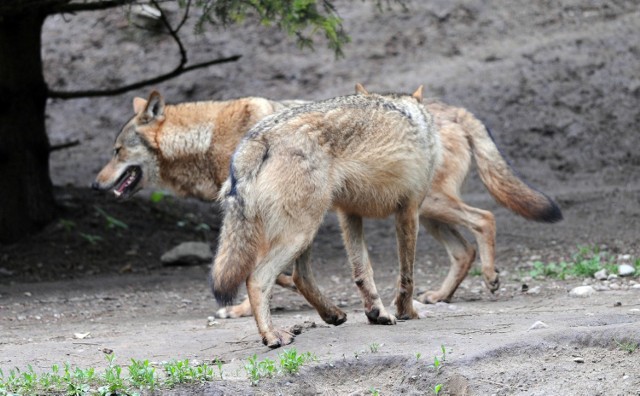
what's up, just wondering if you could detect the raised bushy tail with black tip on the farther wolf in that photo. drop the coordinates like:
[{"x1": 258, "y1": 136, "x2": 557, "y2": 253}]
[{"x1": 457, "y1": 109, "x2": 562, "y2": 223}]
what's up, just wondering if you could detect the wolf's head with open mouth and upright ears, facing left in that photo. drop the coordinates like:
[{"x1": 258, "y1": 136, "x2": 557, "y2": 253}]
[{"x1": 91, "y1": 91, "x2": 165, "y2": 199}]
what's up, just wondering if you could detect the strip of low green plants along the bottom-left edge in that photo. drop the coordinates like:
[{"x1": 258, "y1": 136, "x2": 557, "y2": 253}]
[{"x1": 0, "y1": 354, "x2": 222, "y2": 396}]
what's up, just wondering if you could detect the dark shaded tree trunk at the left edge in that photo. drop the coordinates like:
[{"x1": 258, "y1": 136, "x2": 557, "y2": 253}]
[{"x1": 0, "y1": 10, "x2": 55, "y2": 243}]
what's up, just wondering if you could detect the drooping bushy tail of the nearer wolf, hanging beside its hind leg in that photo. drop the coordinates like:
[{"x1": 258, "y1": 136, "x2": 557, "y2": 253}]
[{"x1": 210, "y1": 195, "x2": 262, "y2": 305}]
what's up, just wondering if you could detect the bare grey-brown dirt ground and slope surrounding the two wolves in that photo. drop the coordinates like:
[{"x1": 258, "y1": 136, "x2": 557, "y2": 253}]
[{"x1": 0, "y1": 0, "x2": 640, "y2": 395}]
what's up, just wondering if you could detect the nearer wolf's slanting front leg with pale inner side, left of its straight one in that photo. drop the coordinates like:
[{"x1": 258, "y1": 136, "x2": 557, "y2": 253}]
[{"x1": 338, "y1": 211, "x2": 396, "y2": 324}]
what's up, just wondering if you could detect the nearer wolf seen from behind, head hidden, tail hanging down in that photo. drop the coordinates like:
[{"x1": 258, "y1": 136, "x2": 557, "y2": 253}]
[{"x1": 211, "y1": 87, "x2": 441, "y2": 348}]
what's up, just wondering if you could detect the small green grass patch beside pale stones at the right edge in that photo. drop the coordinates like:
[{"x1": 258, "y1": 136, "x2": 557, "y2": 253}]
[{"x1": 529, "y1": 246, "x2": 640, "y2": 279}]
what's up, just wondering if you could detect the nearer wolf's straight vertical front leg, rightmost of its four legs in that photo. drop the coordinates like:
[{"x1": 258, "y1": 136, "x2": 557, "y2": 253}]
[{"x1": 396, "y1": 202, "x2": 419, "y2": 319}]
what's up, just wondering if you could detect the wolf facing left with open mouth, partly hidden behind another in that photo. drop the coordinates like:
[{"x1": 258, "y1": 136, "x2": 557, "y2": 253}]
[{"x1": 93, "y1": 86, "x2": 562, "y2": 317}]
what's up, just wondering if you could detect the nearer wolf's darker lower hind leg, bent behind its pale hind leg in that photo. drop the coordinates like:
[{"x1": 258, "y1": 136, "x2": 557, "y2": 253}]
[{"x1": 293, "y1": 246, "x2": 347, "y2": 326}]
